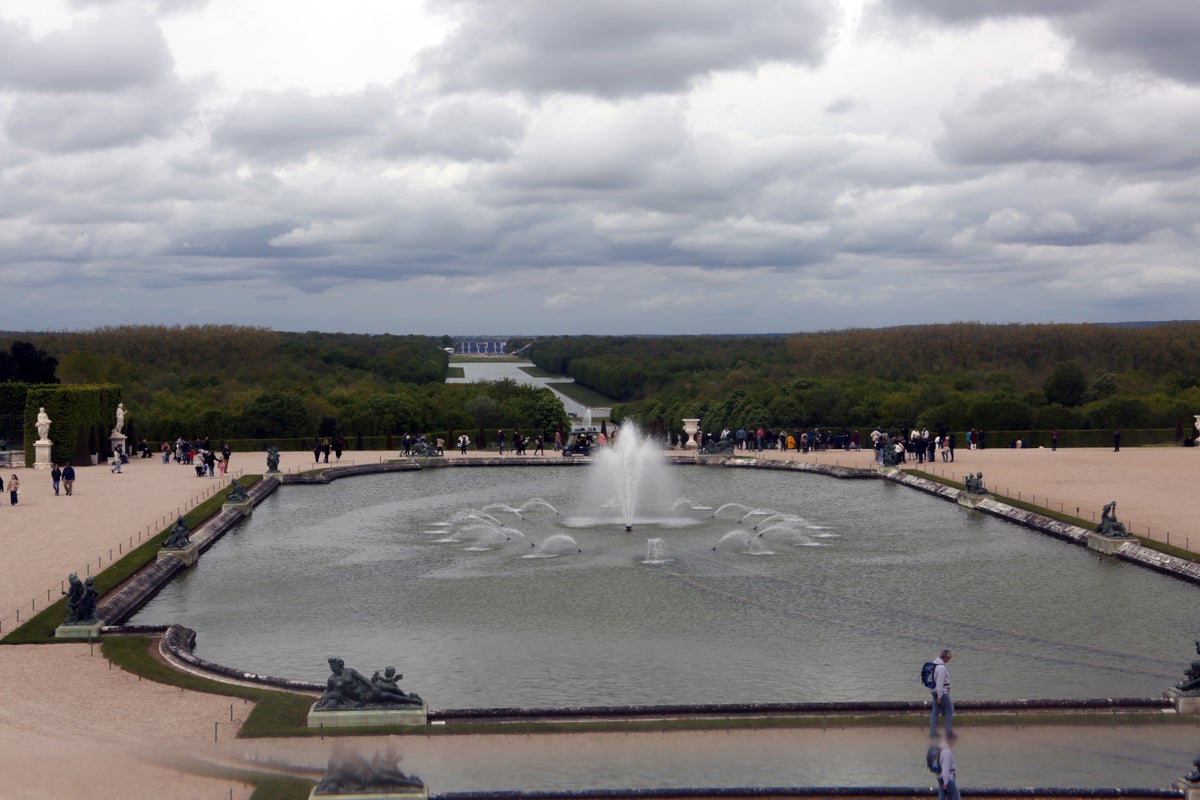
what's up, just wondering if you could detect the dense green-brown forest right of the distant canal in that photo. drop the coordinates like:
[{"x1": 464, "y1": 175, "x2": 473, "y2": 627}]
[{"x1": 530, "y1": 323, "x2": 1200, "y2": 441}]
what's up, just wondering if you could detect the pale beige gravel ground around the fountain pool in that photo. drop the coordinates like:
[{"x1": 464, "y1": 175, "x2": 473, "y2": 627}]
[{"x1": 0, "y1": 447, "x2": 1200, "y2": 800}]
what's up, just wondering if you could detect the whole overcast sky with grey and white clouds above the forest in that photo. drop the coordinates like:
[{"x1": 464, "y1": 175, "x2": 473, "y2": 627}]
[{"x1": 0, "y1": 0, "x2": 1200, "y2": 335}]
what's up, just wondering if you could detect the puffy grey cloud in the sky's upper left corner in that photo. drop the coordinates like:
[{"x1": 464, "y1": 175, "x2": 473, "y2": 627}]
[{"x1": 0, "y1": 12, "x2": 172, "y2": 92}]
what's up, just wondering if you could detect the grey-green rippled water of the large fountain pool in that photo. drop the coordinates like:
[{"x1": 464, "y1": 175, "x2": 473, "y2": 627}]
[{"x1": 132, "y1": 465, "x2": 1198, "y2": 708}]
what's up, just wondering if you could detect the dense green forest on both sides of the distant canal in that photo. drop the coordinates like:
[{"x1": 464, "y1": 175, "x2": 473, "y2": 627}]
[{"x1": 0, "y1": 323, "x2": 1200, "y2": 446}]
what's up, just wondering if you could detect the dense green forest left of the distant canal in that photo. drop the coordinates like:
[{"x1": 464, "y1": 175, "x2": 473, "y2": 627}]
[{"x1": 0, "y1": 325, "x2": 566, "y2": 446}]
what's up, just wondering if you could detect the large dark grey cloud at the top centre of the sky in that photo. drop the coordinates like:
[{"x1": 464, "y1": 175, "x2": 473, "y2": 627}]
[{"x1": 421, "y1": 0, "x2": 834, "y2": 97}]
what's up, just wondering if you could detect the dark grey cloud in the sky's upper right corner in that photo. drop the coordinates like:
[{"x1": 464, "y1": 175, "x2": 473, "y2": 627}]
[{"x1": 881, "y1": 0, "x2": 1200, "y2": 83}]
